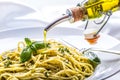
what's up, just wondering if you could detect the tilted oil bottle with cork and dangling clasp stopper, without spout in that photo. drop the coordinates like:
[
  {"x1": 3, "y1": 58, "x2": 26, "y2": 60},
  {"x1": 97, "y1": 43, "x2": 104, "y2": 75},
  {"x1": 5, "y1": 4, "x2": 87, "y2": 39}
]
[{"x1": 67, "y1": 0, "x2": 120, "y2": 44}]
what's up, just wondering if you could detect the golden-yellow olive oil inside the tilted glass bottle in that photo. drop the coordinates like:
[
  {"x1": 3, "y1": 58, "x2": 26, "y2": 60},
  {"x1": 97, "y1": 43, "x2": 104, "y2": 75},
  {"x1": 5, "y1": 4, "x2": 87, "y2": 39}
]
[{"x1": 84, "y1": 0, "x2": 120, "y2": 19}]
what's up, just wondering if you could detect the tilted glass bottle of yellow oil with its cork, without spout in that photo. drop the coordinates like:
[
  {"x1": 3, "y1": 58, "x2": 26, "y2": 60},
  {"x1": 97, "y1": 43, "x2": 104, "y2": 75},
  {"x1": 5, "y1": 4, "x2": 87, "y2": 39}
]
[{"x1": 67, "y1": 0, "x2": 120, "y2": 22}]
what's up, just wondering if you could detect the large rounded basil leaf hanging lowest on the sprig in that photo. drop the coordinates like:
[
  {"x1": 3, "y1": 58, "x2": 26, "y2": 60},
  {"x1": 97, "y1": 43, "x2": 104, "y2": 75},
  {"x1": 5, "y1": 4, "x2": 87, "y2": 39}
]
[{"x1": 20, "y1": 47, "x2": 33, "y2": 62}]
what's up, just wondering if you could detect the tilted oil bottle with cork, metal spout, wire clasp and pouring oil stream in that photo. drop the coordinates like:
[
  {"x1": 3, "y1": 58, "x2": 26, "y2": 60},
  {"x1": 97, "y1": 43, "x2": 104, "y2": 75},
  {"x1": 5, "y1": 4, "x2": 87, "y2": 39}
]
[{"x1": 44, "y1": 0, "x2": 120, "y2": 43}]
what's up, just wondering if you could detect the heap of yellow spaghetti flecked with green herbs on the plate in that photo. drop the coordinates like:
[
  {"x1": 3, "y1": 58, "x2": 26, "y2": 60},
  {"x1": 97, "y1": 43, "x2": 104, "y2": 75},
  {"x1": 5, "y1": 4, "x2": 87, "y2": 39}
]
[{"x1": 0, "y1": 40, "x2": 94, "y2": 80}]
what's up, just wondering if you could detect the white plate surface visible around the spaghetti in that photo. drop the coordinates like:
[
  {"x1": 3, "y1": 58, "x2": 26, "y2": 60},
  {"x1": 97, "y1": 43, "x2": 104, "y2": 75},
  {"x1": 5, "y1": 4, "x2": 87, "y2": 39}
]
[{"x1": 0, "y1": 27, "x2": 120, "y2": 80}]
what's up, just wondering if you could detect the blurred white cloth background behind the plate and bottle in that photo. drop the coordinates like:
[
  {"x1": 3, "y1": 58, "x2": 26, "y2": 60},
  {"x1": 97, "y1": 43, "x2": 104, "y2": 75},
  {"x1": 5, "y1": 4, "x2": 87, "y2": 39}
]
[{"x1": 0, "y1": 0, "x2": 120, "y2": 40}]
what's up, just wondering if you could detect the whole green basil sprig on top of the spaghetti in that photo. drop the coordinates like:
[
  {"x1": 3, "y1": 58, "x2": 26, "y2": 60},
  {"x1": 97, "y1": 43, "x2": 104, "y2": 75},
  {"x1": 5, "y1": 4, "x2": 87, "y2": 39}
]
[{"x1": 20, "y1": 38, "x2": 49, "y2": 62}]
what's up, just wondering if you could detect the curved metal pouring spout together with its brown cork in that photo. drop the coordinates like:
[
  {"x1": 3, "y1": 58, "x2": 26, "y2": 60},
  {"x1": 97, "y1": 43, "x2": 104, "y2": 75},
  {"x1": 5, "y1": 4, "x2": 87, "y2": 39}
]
[{"x1": 44, "y1": 6, "x2": 85, "y2": 31}]
